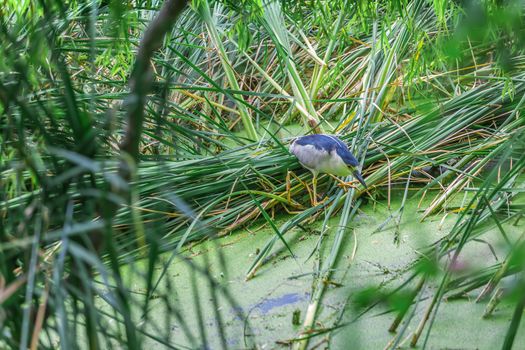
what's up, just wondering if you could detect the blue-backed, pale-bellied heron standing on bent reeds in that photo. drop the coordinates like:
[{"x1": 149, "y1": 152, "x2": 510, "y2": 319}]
[{"x1": 289, "y1": 134, "x2": 367, "y2": 205}]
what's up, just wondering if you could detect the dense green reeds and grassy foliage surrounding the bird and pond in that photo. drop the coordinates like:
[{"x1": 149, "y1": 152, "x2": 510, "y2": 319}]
[{"x1": 0, "y1": 0, "x2": 525, "y2": 348}]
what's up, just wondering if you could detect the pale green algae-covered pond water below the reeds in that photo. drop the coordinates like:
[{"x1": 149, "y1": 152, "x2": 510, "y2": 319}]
[{"x1": 116, "y1": 193, "x2": 525, "y2": 349}]
